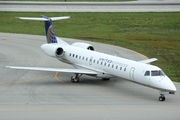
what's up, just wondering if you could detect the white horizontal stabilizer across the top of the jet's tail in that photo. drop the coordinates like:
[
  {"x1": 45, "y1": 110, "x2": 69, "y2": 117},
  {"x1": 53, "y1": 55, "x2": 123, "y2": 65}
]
[{"x1": 16, "y1": 16, "x2": 70, "y2": 21}]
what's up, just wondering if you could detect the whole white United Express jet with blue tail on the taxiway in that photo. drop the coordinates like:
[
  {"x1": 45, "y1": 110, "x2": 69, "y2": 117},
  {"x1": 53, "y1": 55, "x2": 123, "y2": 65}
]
[{"x1": 6, "y1": 15, "x2": 177, "y2": 101}]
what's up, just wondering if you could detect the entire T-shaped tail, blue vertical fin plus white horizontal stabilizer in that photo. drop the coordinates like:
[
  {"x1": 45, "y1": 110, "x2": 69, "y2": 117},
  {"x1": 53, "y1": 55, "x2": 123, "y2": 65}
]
[{"x1": 18, "y1": 15, "x2": 70, "y2": 43}]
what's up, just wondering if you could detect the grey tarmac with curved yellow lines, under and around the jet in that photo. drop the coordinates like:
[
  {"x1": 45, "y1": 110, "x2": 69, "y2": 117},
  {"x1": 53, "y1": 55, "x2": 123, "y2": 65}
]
[{"x1": 0, "y1": 33, "x2": 180, "y2": 120}]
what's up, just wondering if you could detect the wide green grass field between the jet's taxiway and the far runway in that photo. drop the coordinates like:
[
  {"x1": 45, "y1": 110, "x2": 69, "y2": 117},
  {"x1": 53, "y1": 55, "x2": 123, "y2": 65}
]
[{"x1": 0, "y1": 12, "x2": 180, "y2": 82}]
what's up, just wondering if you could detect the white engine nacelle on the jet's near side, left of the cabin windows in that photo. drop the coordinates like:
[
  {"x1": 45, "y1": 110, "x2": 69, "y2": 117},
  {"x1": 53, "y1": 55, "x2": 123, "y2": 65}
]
[{"x1": 41, "y1": 44, "x2": 65, "y2": 57}]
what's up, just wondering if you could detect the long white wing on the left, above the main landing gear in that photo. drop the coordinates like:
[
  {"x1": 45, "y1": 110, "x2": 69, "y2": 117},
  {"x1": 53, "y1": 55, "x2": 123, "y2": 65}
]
[{"x1": 6, "y1": 66, "x2": 97, "y2": 75}]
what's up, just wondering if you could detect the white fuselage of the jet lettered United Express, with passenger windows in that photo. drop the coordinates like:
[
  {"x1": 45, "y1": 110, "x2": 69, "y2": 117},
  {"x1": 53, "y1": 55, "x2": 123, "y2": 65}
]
[{"x1": 58, "y1": 45, "x2": 176, "y2": 92}]
